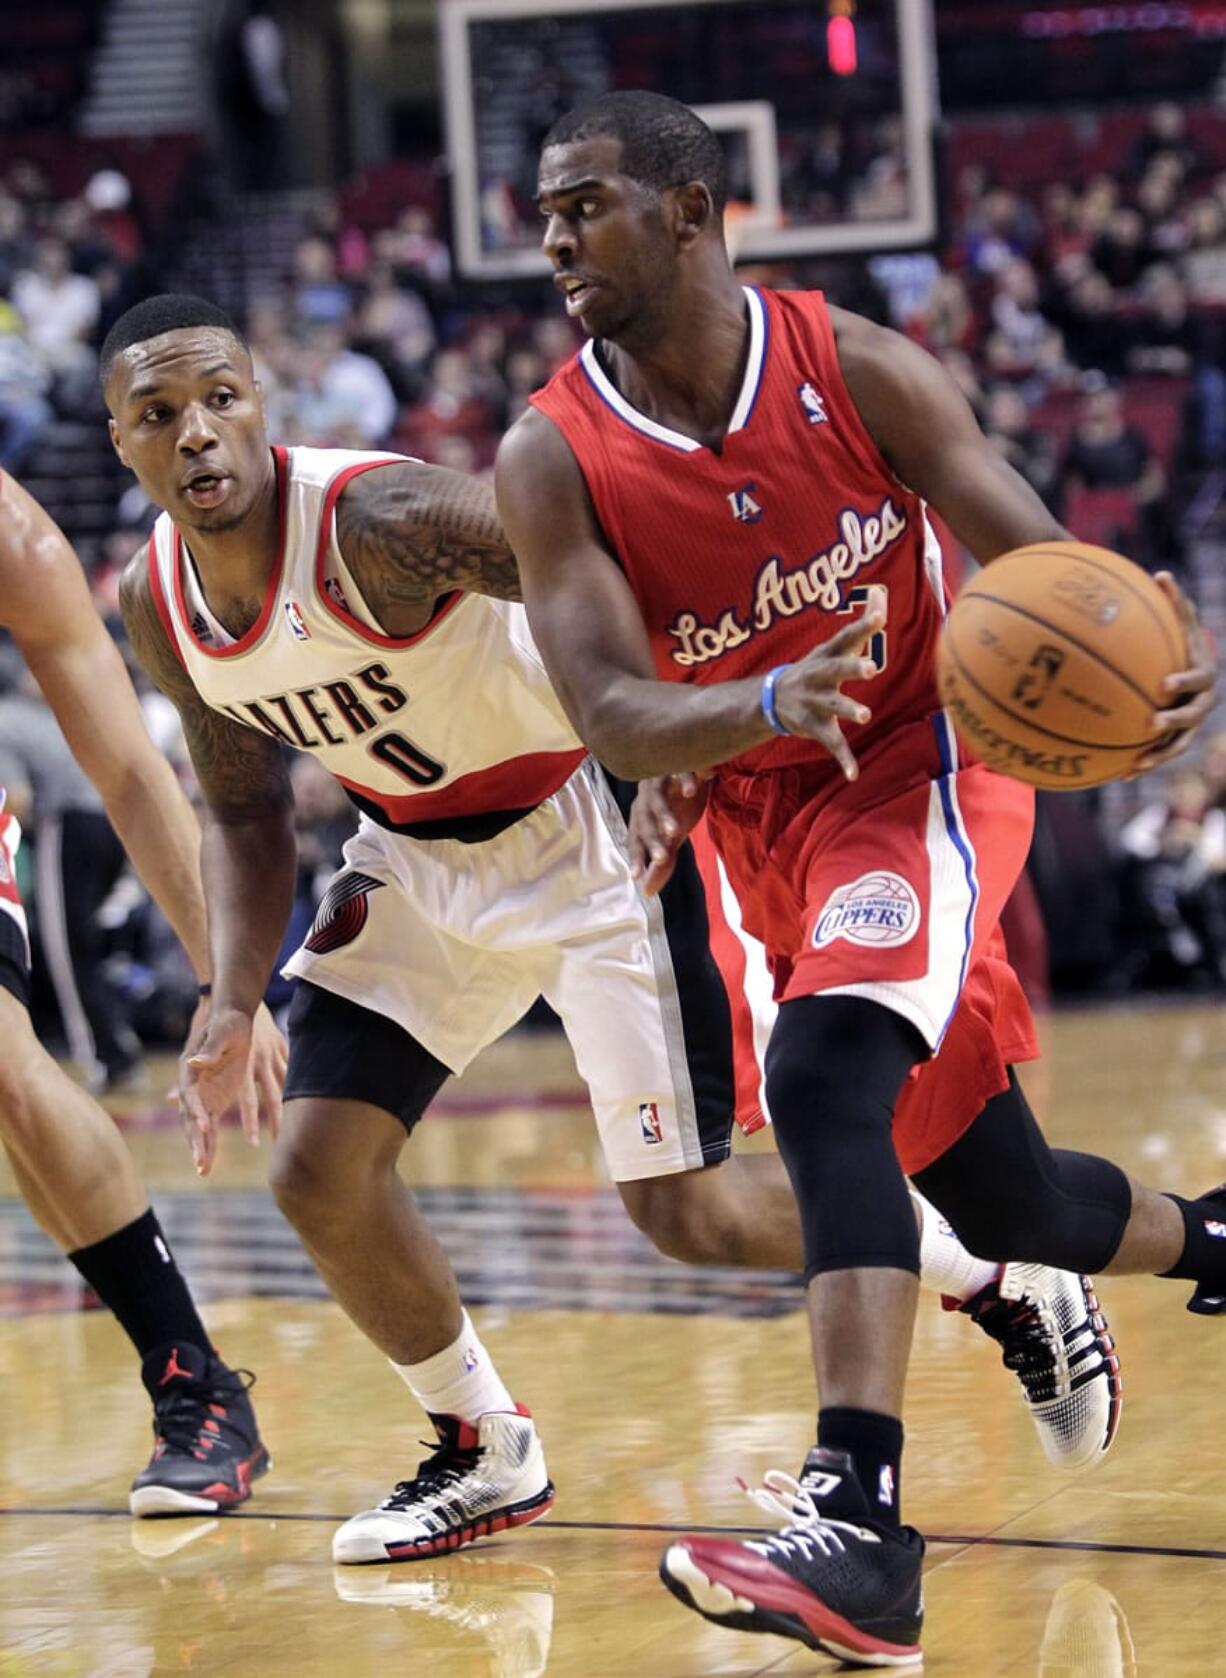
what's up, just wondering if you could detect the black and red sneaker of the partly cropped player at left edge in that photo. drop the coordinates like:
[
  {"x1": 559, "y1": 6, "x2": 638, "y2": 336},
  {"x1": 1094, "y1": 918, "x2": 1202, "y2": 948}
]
[{"x1": 127, "y1": 1341, "x2": 272, "y2": 1515}]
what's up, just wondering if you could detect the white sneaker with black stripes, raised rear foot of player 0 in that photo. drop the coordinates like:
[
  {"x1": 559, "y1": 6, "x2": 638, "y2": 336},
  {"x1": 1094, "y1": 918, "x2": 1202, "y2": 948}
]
[{"x1": 959, "y1": 1264, "x2": 1124, "y2": 1468}]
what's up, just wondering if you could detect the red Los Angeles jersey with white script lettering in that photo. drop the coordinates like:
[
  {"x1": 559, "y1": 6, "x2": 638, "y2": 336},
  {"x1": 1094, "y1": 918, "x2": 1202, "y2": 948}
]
[{"x1": 532, "y1": 287, "x2": 946, "y2": 780}]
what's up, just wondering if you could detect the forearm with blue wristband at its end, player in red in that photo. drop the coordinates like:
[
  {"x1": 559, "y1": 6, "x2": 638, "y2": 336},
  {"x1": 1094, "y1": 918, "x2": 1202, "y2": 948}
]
[{"x1": 572, "y1": 676, "x2": 773, "y2": 780}]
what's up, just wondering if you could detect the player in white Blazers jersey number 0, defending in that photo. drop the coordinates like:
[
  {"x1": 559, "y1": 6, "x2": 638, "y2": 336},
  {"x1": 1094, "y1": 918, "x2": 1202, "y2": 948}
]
[{"x1": 110, "y1": 295, "x2": 1117, "y2": 1562}]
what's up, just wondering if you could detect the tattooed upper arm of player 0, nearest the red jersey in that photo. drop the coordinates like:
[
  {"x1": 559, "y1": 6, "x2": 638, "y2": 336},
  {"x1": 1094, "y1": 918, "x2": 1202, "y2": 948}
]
[{"x1": 337, "y1": 460, "x2": 522, "y2": 634}]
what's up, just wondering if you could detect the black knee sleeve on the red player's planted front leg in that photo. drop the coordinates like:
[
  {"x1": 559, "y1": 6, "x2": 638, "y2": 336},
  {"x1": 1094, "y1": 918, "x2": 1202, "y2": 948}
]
[{"x1": 766, "y1": 997, "x2": 926, "y2": 1282}]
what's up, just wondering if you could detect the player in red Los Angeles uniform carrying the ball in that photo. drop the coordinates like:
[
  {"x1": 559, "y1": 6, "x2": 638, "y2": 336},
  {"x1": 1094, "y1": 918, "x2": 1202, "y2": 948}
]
[{"x1": 496, "y1": 94, "x2": 1226, "y2": 1665}]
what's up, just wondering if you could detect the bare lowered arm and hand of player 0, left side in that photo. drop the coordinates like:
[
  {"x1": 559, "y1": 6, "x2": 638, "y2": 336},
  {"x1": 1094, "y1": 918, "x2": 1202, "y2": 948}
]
[{"x1": 119, "y1": 552, "x2": 297, "y2": 1171}]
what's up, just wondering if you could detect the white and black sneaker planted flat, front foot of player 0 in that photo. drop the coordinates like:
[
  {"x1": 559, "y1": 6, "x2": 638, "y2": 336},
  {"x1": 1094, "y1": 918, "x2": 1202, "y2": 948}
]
[{"x1": 332, "y1": 1404, "x2": 553, "y2": 1564}]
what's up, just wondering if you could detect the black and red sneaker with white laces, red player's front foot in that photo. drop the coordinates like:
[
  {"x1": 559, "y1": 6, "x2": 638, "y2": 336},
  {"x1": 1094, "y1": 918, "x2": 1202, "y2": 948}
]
[{"x1": 659, "y1": 1448, "x2": 924, "y2": 1666}]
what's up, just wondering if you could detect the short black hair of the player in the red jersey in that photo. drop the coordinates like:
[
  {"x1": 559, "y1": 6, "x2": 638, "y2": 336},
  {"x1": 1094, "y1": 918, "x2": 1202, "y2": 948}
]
[{"x1": 540, "y1": 91, "x2": 728, "y2": 215}]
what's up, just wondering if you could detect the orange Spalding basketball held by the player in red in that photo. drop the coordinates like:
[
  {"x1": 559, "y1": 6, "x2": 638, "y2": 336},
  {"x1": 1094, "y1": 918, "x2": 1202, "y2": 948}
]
[{"x1": 938, "y1": 542, "x2": 1187, "y2": 789}]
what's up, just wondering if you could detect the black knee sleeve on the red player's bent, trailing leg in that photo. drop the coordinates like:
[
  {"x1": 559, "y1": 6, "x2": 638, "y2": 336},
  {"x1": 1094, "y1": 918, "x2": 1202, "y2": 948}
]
[{"x1": 914, "y1": 1079, "x2": 1132, "y2": 1270}]
